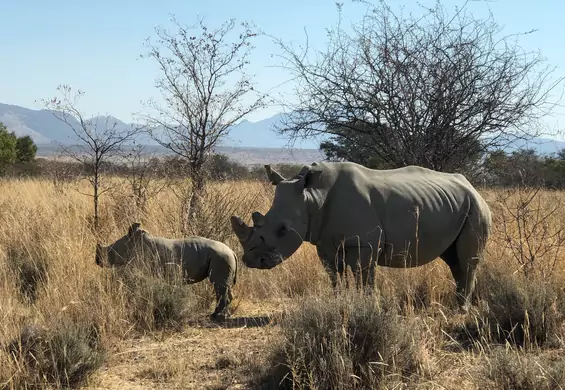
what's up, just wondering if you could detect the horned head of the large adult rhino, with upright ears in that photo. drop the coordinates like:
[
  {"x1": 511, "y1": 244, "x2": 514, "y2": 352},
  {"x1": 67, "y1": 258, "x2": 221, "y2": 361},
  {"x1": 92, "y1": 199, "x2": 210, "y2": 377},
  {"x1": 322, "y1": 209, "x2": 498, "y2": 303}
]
[{"x1": 231, "y1": 165, "x2": 321, "y2": 269}]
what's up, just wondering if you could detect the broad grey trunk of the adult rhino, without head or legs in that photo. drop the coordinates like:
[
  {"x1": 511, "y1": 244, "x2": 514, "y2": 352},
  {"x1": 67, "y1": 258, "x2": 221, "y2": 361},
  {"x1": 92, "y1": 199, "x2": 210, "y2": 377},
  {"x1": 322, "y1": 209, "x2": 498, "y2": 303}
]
[{"x1": 312, "y1": 163, "x2": 482, "y2": 263}]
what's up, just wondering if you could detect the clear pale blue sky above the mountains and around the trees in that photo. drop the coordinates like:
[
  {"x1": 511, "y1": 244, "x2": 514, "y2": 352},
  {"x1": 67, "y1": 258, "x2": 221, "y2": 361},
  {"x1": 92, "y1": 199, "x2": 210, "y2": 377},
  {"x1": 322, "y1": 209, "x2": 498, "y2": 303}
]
[{"x1": 0, "y1": 0, "x2": 565, "y2": 133}]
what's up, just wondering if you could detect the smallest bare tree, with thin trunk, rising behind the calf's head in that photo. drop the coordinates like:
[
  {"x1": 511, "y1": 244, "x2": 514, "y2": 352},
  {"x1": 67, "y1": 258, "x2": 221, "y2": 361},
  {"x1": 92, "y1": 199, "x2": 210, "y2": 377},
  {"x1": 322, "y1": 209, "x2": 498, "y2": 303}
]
[{"x1": 43, "y1": 85, "x2": 138, "y2": 231}]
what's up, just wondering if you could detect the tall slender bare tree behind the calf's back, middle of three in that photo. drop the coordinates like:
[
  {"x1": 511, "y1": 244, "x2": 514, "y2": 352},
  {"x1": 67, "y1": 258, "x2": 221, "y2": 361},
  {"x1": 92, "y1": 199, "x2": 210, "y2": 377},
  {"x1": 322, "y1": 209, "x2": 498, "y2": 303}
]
[{"x1": 139, "y1": 17, "x2": 265, "y2": 232}]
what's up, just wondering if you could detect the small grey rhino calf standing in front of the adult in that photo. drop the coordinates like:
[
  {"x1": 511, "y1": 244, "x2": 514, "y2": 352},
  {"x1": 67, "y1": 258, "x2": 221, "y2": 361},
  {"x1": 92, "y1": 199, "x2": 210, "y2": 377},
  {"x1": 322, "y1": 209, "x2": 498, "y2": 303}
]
[{"x1": 96, "y1": 223, "x2": 237, "y2": 319}]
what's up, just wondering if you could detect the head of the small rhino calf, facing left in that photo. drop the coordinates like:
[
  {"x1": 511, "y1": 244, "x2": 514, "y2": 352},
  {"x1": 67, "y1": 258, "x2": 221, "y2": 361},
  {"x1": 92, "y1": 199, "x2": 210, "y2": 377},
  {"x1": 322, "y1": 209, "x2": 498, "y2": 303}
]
[{"x1": 96, "y1": 222, "x2": 147, "y2": 267}]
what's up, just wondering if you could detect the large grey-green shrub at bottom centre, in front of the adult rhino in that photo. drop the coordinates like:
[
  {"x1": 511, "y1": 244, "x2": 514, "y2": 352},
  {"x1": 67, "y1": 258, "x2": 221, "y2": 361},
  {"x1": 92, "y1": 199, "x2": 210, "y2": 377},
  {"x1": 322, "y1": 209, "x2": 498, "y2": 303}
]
[{"x1": 262, "y1": 292, "x2": 421, "y2": 389}]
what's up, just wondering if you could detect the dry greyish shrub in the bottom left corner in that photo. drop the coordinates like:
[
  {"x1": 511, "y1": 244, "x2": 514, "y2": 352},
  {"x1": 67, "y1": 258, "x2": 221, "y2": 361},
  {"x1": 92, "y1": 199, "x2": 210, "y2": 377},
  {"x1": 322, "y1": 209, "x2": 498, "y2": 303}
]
[{"x1": 0, "y1": 320, "x2": 105, "y2": 389}]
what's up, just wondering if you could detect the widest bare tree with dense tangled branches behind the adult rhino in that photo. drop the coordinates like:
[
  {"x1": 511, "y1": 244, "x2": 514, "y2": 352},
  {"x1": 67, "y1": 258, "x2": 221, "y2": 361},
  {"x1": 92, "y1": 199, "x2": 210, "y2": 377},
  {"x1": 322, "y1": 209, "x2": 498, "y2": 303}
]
[{"x1": 277, "y1": 0, "x2": 563, "y2": 171}]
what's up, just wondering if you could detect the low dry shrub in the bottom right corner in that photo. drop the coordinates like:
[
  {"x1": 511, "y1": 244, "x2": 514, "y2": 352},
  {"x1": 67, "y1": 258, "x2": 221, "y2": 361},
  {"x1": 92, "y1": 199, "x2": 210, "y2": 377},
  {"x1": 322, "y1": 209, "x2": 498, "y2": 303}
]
[{"x1": 487, "y1": 349, "x2": 565, "y2": 390}]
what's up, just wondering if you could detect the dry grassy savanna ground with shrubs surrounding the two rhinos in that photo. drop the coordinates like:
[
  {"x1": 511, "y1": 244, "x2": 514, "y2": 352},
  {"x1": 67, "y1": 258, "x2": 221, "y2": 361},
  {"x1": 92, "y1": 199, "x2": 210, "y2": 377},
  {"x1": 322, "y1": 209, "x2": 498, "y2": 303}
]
[{"x1": 0, "y1": 180, "x2": 565, "y2": 389}]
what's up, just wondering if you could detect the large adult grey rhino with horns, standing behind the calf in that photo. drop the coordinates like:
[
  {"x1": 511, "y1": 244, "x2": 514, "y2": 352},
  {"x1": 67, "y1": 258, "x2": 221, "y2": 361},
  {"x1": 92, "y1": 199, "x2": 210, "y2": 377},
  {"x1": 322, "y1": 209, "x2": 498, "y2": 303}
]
[{"x1": 231, "y1": 162, "x2": 492, "y2": 311}]
